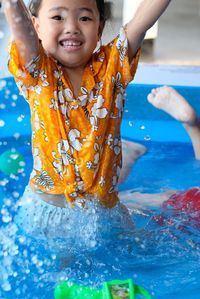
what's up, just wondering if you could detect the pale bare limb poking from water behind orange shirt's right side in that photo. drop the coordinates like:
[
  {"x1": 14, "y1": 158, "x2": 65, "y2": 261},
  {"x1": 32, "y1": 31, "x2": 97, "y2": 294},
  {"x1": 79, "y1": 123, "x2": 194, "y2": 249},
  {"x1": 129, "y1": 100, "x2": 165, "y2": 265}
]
[{"x1": 119, "y1": 139, "x2": 146, "y2": 183}]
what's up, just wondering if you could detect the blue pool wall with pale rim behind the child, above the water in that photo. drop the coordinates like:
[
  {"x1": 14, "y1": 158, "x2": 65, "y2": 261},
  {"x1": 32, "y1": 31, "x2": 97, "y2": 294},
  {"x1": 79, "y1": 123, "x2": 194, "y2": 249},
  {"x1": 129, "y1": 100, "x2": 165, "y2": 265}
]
[{"x1": 0, "y1": 66, "x2": 200, "y2": 142}]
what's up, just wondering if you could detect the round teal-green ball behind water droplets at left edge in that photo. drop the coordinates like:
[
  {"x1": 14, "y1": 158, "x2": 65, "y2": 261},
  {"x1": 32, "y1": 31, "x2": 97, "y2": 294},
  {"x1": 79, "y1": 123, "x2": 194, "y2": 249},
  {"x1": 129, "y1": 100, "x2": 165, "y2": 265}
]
[{"x1": 0, "y1": 150, "x2": 25, "y2": 175}]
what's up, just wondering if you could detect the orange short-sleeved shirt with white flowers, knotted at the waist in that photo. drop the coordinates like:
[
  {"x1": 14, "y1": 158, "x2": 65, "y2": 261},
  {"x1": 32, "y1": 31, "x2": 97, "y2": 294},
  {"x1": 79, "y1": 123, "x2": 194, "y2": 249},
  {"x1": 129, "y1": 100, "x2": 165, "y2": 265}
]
[{"x1": 9, "y1": 28, "x2": 139, "y2": 207}]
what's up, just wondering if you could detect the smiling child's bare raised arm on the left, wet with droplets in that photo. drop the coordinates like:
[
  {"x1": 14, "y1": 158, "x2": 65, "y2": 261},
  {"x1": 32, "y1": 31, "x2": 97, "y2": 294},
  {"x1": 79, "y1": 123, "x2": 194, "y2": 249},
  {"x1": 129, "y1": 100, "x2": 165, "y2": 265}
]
[{"x1": 3, "y1": 0, "x2": 39, "y2": 65}]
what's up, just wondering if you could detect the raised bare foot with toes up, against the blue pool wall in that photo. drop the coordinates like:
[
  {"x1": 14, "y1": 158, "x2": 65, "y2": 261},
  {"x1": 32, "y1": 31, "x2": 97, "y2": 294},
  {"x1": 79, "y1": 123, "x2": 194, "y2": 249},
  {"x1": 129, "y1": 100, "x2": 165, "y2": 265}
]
[{"x1": 147, "y1": 86, "x2": 197, "y2": 124}]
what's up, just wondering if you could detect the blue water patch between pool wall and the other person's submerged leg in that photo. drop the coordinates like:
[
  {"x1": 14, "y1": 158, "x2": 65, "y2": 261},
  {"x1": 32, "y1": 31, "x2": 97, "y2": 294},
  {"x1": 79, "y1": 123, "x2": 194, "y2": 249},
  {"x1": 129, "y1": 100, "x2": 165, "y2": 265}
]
[{"x1": 120, "y1": 142, "x2": 200, "y2": 193}]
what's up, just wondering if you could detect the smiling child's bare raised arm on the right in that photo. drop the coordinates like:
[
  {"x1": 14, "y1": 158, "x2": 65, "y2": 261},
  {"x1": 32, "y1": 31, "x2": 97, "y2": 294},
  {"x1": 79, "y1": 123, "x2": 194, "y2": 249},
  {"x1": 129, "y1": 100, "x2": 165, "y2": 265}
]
[{"x1": 127, "y1": 0, "x2": 171, "y2": 61}]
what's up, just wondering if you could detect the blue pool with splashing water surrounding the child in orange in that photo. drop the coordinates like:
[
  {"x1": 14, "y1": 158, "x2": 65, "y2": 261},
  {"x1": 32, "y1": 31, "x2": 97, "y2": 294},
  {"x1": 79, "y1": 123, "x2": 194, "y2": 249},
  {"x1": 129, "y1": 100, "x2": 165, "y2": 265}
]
[{"x1": 0, "y1": 78, "x2": 200, "y2": 299}]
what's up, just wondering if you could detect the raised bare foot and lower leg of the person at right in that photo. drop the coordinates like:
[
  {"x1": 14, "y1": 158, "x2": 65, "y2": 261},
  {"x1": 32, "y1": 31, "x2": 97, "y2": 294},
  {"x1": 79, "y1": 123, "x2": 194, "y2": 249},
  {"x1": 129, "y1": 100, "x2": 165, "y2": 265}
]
[{"x1": 147, "y1": 86, "x2": 200, "y2": 160}]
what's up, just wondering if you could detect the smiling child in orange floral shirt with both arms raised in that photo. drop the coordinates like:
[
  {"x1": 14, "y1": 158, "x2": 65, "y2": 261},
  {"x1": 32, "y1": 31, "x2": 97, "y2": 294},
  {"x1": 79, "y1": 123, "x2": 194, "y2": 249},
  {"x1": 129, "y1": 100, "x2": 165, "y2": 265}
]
[{"x1": 4, "y1": 0, "x2": 170, "y2": 246}]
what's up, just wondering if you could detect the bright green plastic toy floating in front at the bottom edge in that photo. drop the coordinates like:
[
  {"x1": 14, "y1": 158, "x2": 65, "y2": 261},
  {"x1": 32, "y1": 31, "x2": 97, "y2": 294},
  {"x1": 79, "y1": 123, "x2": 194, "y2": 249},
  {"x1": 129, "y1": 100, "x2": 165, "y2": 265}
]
[{"x1": 54, "y1": 279, "x2": 151, "y2": 299}]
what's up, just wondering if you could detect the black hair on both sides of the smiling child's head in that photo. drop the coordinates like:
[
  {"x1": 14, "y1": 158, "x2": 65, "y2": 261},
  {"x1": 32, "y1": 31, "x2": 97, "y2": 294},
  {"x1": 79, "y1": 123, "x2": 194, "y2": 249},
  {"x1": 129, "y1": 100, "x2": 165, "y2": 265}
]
[{"x1": 28, "y1": 0, "x2": 105, "y2": 21}]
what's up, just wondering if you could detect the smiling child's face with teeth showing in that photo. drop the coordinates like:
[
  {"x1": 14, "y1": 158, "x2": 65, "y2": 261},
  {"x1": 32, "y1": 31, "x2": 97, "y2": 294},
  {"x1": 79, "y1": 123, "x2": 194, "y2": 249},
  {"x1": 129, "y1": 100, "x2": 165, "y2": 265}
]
[{"x1": 33, "y1": 0, "x2": 103, "y2": 68}]
